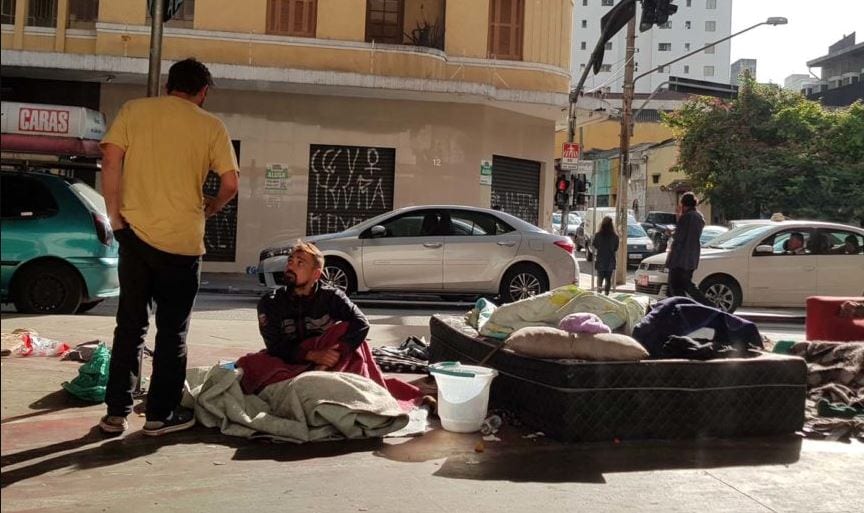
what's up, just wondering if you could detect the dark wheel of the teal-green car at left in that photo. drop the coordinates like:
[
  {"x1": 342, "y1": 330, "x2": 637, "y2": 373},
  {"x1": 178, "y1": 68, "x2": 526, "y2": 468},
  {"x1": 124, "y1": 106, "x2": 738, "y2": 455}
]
[{"x1": 13, "y1": 262, "x2": 84, "y2": 314}]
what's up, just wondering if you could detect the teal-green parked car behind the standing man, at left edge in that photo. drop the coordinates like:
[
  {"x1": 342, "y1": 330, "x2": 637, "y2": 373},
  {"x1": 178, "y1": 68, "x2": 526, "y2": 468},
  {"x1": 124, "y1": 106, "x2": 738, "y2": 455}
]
[{"x1": 0, "y1": 170, "x2": 120, "y2": 314}]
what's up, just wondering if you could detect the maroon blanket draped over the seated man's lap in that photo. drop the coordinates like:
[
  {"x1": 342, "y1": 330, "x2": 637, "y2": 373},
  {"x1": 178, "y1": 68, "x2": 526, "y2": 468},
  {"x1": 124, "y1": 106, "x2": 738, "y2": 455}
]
[{"x1": 237, "y1": 322, "x2": 422, "y2": 410}]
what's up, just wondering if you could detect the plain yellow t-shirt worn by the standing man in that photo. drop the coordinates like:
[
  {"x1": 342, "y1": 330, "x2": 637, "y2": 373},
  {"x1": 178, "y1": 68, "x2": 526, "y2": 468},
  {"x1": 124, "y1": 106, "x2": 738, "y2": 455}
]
[{"x1": 102, "y1": 95, "x2": 239, "y2": 255}]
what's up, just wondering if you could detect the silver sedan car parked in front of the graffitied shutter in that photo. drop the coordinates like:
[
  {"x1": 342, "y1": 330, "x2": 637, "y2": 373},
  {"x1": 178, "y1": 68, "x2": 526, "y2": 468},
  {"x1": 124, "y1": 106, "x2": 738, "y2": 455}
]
[{"x1": 258, "y1": 205, "x2": 579, "y2": 302}]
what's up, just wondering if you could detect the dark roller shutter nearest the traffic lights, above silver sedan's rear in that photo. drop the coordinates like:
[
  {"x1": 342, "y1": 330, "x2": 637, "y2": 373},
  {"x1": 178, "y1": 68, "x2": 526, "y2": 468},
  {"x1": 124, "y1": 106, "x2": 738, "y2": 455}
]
[{"x1": 492, "y1": 155, "x2": 540, "y2": 225}]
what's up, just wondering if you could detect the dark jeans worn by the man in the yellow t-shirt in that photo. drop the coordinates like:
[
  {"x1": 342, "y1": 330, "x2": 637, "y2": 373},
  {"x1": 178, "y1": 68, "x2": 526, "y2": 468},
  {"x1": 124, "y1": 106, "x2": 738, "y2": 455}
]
[{"x1": 105, "y1": 229, "x2": 201, "y2": 420}]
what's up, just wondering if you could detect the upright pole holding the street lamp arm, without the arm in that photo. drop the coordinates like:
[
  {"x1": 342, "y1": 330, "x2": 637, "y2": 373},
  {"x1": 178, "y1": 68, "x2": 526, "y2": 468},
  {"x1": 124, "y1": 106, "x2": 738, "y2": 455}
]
[{"x1": 615, "y1": 18, "x2": 636, "y2": 285}]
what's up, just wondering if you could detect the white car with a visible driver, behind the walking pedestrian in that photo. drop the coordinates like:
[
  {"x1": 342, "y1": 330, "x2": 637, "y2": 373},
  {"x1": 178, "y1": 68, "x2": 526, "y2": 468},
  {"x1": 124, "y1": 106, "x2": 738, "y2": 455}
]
[{"x1": 635, "y1": 221, "x2": 864, "y2": 312}]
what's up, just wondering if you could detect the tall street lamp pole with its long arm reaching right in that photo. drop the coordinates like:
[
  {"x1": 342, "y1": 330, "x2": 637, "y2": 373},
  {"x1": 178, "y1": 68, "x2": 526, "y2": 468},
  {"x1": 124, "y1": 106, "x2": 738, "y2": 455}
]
[{"x1": 615, "y1": 16, "x2": 789, "y2": 283}]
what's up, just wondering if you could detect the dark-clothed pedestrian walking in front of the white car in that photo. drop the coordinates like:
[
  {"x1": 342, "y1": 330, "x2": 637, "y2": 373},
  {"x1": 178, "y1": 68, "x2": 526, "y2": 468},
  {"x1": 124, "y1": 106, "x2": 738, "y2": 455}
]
[{"x1": 666, "y1": 192, "x2": 714, "y2": 306}]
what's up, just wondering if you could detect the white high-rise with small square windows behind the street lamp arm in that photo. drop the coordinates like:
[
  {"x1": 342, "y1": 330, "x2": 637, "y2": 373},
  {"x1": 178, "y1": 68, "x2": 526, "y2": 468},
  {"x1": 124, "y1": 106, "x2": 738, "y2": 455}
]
[{"x1": 570, "y1": 0, "x2": 732, "y2": 93}]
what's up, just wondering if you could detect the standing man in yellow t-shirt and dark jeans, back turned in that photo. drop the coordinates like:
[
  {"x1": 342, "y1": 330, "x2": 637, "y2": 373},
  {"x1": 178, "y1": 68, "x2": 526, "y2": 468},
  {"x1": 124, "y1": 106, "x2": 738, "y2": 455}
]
[{"x1": 99, "y1": 59, "x2": 238, "y2": 436}]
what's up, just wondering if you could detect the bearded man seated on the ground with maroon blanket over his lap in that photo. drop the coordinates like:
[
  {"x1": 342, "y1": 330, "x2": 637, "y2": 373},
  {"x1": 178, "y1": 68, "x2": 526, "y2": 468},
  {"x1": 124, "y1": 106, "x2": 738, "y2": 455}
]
[{"x1": 237, "y1": 242, "x2": 421, "y2": 402}]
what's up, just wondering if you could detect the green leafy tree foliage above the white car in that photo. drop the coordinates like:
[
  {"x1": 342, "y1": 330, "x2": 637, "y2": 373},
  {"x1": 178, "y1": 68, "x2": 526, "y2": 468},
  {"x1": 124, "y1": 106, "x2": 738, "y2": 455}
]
[{"x1": 663, "y1": 79, "x2": 864, "y2": 225}]
